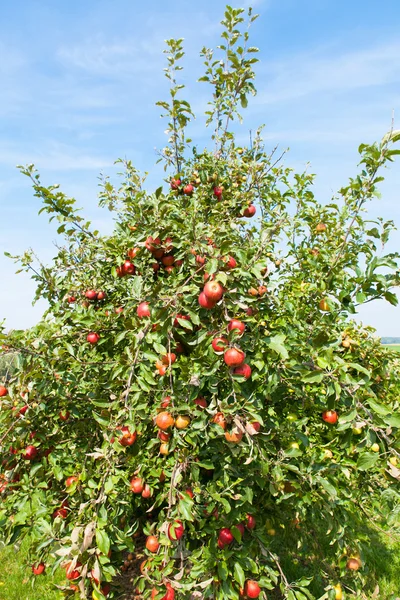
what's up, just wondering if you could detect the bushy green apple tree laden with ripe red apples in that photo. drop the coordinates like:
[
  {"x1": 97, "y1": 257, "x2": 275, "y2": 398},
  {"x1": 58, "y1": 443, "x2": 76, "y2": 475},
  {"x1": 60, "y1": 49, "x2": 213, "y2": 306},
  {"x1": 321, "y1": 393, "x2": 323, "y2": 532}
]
[{"x1": 0, "y1": 7, "x2": 400, "y2": 600}]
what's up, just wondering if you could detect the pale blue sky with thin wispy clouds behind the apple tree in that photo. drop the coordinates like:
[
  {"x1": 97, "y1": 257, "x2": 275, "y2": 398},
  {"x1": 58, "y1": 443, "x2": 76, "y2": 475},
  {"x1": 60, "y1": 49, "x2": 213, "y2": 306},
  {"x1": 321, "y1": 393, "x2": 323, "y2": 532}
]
[{"x1": 0, "y1": 0, "x2": 400, "y2": 336}]
